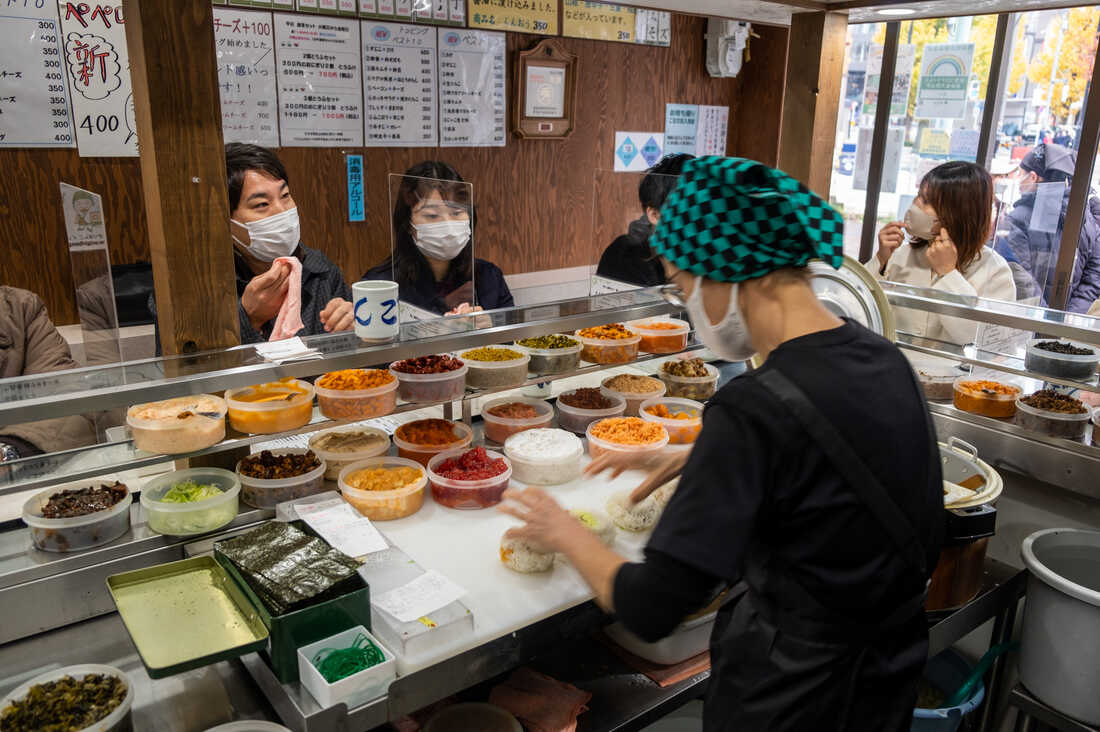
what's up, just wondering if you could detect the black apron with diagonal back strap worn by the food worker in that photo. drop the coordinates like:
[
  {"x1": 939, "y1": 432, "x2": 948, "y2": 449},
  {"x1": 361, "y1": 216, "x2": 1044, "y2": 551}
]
[{"x1": 704, "y1": 370, "x2": 939, "y2": 732}]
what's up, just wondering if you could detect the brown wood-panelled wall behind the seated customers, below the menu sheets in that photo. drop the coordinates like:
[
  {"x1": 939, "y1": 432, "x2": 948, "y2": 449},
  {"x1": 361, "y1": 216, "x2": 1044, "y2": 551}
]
[{"x1": 0, "y1": 15, "x2": 788, "y2": 323}]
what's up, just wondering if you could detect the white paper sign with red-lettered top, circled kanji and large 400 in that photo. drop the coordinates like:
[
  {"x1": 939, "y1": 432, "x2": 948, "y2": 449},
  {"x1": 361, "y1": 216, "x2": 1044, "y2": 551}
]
[{"x1": 57, "y1": 0, "x2": 138, "y2": 157}]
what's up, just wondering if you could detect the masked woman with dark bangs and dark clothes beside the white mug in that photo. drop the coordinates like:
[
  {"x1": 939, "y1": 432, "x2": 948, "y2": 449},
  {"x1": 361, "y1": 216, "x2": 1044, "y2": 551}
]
[{"x1": 363, "y1": 161, "x2": 514, "y2": 315}]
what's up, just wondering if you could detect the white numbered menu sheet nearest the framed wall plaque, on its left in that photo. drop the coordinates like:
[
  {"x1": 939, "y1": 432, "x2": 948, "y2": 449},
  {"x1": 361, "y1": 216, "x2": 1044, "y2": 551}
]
[{"x1": 438, "y1": 28, "x2": 508, "y2": 148}]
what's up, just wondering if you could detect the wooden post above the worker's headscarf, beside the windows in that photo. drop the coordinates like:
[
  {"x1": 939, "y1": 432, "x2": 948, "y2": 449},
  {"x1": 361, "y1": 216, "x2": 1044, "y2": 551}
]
[{"x1": 779, "y1": 12, "x2": 848, "y2": 200}]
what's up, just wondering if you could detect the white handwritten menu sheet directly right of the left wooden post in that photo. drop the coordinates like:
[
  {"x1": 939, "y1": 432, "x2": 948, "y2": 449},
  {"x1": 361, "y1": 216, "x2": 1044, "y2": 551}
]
[{"x1": 213, "y1": 8, "x2": 278, "y2": 148}]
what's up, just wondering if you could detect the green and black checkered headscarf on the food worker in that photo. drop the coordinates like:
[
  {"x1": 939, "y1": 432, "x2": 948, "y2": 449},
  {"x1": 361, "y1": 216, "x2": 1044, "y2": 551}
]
[{"x1": 649, "y1": 155, "x2": 844, "y2": 282}]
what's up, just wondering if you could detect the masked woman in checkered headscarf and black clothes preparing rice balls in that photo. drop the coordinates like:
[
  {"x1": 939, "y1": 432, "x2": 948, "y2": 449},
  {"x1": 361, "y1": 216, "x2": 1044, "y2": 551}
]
[{"x1": 502, "y1": 157, "x2": 943, "y2": 732}]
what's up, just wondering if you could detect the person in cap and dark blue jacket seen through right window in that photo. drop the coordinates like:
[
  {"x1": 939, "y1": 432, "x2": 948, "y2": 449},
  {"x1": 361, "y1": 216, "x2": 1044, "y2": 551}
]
[{"x1": 993, "y1": 143, "x2": 1100, "y2": 313}]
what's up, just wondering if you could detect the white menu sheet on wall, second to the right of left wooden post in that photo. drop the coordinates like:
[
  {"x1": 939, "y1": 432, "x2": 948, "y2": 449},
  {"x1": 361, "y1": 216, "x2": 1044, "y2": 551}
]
[{"x1": 275, "y1": 13, "x2": 363, "y2": 148}]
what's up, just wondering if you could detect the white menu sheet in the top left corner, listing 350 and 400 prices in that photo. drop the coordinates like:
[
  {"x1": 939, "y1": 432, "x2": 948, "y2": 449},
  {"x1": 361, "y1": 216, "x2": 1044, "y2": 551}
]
[{"x1": 0, "y1": 0, "x2": 76, "y2": 148}]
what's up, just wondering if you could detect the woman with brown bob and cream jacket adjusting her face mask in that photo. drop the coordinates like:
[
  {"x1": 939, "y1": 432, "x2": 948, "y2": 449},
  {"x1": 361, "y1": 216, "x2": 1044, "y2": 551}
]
[{"x1": 868, "y1": 162, "x2": 1016, "y2": 345}]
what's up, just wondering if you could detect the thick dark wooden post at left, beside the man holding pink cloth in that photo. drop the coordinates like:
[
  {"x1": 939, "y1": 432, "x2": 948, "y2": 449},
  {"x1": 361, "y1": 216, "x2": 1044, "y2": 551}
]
[{"x1": 123, "y1": 0, "x2": 241, "y2": 356}]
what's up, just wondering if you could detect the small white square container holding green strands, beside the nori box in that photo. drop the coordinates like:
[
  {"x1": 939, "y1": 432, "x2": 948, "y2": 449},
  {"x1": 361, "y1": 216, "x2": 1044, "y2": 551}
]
[{"x1": 298, "y1": 625, "x2": 397, "y2": 709}]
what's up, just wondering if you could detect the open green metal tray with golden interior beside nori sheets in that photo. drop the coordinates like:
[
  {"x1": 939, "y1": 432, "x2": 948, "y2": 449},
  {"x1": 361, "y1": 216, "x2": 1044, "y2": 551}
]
[{"x1": 107, "y1": 557, "x2": 268, "y2": 679}]
